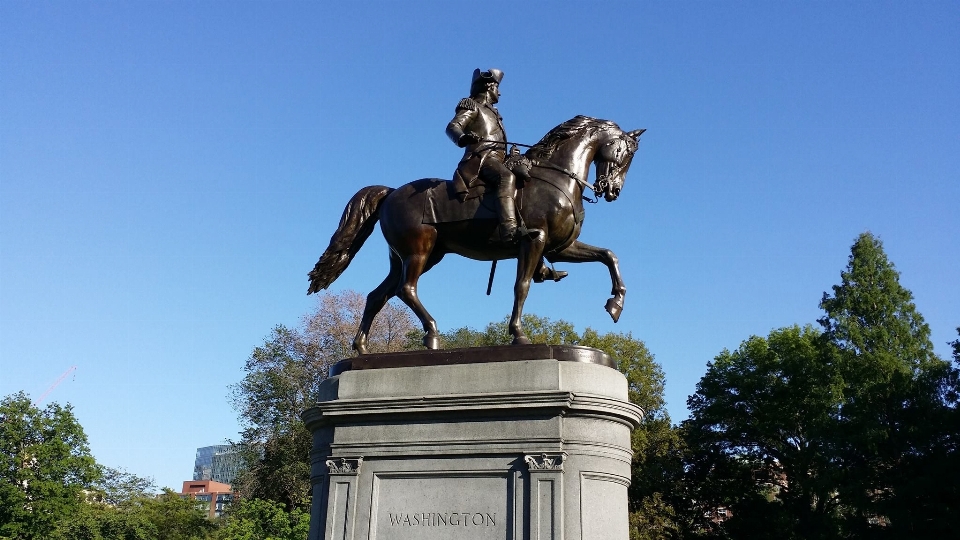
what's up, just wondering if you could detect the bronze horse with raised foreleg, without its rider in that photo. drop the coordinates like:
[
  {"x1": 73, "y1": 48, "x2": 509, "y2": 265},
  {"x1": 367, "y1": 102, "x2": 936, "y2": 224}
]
[{"x1": 307, "y1": 116, "x2": 645, "y2": 354}]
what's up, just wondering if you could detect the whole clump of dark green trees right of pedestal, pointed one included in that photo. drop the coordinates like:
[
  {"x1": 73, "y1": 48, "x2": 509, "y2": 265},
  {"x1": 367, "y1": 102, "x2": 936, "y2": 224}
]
[{"x1": 675, "y1": 233, "x2": 960, "y2": 539}]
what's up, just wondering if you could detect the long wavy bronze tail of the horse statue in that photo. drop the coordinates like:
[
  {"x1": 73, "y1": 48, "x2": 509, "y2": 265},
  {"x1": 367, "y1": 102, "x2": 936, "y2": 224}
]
[{"x1": 307, "y1": 186, "x2": 393, "y2": 294}]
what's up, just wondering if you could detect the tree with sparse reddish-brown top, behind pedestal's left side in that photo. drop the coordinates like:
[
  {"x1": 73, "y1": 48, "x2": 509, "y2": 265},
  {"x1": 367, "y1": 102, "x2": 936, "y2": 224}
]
[{"x1": 231, "y1": 291, "x2": 414, "y2": 509}]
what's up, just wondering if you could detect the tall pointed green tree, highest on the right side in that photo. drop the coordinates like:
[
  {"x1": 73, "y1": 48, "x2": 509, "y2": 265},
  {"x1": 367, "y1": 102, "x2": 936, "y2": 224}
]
[{"x1": 819, "y1": 233, "x2": 956, "y2": 536}]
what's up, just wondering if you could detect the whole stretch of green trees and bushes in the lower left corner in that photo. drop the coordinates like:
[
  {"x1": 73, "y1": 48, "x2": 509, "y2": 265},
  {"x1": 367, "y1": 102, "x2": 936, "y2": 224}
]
[{"x1": 0, "y1": 392, "x2": 214, "y2": 540}]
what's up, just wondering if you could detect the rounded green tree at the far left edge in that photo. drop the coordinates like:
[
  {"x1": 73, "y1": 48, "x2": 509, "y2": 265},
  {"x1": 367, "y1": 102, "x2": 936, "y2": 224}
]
[{"x1": 0, "y1": 392, "x2": 100, "y2": 539}]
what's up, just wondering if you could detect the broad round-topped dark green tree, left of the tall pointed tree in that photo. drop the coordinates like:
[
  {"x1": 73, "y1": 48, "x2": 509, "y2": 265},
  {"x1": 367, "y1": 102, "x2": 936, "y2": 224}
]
[{"x1": 684, "y1": 326, "x2": 841, "y2": 539}]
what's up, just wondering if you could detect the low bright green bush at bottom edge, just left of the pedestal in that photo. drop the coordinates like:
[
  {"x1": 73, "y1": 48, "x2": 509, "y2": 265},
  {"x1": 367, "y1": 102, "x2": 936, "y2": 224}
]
[{"x1": 216, "y1": 499, "x2": 310, "y2": 540}]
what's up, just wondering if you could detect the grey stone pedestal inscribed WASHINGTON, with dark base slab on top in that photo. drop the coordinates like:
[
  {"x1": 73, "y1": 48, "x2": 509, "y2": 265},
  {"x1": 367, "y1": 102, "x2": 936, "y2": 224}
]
[{"x1": 303, "y1": 346, "x2": 642, "y2": 540}]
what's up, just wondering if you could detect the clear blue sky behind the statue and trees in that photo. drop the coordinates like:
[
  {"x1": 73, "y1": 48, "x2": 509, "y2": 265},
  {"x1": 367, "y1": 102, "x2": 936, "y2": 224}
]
[{"x1": 0, "y1": 0, "x2": 960, "y2": 487}]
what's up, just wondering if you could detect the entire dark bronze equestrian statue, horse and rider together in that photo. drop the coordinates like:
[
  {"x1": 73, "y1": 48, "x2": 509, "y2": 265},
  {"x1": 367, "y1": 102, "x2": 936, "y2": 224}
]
[{"x1": 307, "y1": 69, "x2": 645, "y2": 354}]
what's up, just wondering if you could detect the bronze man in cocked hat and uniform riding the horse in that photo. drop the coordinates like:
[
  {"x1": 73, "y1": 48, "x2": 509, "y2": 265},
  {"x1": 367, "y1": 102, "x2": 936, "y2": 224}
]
[{"x1": 447, "y1": 69, "x2": 518, "y2": 243}]
